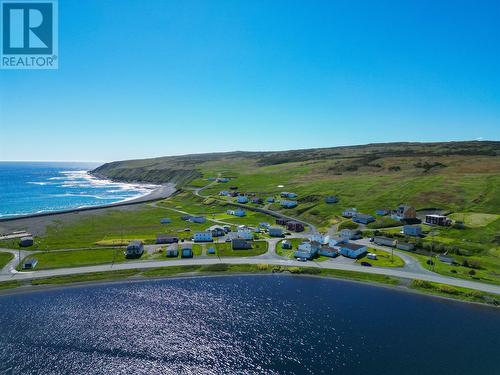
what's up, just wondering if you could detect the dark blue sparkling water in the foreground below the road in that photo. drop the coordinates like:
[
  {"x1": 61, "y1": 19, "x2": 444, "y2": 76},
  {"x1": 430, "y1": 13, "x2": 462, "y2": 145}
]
[{"x1": 0, "y1": 275, "x2": 500, "y2": 375}]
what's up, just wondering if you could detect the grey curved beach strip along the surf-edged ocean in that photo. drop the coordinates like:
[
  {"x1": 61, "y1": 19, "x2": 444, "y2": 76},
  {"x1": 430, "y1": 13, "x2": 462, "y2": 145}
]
[{"x1": 0, "y1": 183, "x2": 177, "y2": 223}]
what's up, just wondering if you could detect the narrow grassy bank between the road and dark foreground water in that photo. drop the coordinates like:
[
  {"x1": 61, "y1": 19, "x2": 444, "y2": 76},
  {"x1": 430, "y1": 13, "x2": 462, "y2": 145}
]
[{"x1": 0, "y1": 271, "x2": 499, "y2": 309}]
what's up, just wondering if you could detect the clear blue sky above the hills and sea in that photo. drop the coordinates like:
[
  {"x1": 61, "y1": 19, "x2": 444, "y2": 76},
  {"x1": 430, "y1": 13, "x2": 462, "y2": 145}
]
[{"x1": 0, "y1": 0, "x2": 500, "y2": 161}]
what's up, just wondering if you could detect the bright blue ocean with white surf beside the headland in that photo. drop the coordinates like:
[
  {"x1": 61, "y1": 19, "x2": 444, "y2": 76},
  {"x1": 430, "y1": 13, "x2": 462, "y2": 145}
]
[{"x1": 0, "y1": 162, "x2": 154, "y2": 217}]
